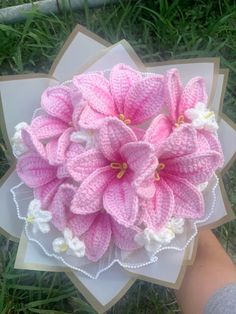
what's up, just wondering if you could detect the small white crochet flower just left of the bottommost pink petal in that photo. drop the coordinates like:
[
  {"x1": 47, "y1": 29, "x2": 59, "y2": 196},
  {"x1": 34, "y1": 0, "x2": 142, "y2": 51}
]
[{"x1": 52, "y1": 228, "x2": 85, "y2": 257}]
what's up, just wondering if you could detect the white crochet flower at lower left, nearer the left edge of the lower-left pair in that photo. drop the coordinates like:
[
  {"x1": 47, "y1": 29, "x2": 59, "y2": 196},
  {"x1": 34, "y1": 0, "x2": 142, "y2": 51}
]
[{"x1": 26, "y1": 199, "x2": 52, "y2": 233}]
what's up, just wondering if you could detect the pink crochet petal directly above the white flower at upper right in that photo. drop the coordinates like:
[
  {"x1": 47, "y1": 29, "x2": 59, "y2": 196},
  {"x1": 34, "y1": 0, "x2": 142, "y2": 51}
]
[{"x1": 178, "y1": 76, "x2": 207, "y2": 116}]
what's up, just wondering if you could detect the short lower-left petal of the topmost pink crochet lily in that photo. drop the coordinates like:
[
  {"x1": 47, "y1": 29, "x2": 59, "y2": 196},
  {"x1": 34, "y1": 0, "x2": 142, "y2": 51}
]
[{"x1": 79, "y1": 106, "x2": 106, "y2": 130}]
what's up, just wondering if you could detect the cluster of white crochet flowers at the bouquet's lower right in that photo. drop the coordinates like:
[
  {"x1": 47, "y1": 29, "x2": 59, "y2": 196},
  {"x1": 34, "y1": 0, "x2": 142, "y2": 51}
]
[{"x1": 134, "y1": 217, "x2": 184, "y2": 252}]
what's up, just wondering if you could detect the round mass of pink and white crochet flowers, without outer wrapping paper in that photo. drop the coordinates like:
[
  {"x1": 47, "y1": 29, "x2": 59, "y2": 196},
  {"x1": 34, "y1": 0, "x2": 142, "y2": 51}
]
[{"x1": 12, "y1": 64, "x2": 223, "y2": 269}]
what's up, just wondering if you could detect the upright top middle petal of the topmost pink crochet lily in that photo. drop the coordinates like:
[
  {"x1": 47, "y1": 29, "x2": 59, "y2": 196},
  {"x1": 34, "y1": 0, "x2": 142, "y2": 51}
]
[{"x1": 110, "y1": 64, "x2": 142, "y2": 113}]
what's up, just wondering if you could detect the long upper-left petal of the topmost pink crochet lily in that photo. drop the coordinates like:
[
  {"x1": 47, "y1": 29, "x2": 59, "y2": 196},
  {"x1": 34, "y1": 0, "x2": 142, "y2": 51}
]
[{"x1": 73, "y1": 73, "x2": 117, "y2": 116}]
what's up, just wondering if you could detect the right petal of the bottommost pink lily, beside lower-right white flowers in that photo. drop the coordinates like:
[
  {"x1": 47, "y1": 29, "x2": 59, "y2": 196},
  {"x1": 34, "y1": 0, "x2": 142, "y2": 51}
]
[{"x1": 111, "y1": 219, "x2": 139, "y2": 251}]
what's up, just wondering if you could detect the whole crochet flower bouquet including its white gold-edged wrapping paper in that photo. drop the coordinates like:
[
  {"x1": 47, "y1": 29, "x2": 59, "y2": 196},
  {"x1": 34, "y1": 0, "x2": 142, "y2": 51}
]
[{"x1": 0, "y1": 26, "x2": 236, "y2": 313}]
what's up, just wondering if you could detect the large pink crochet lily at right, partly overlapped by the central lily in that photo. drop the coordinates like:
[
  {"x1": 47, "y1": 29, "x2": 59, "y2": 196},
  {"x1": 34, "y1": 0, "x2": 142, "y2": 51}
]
[{"x1": 142, "y1": 119, "x2": 221, "y2": 230}]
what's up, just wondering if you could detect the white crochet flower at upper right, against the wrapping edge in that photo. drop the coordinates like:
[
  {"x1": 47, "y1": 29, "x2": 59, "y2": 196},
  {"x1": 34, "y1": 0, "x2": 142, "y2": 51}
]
[{"x1": 184, "y1": 102, "x2": 218, "y2": 132}]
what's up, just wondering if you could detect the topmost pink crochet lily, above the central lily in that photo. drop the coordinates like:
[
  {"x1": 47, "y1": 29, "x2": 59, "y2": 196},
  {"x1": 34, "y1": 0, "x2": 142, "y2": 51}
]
[{"x1": 73, "y1": 64, "x2": 164, "y2": 133}]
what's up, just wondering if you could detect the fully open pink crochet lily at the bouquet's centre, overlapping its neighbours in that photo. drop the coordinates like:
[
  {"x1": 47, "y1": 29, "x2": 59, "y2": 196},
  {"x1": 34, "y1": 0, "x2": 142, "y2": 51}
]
[{"x1": 68, "y1": 118, "x2": 157, "y2": 227}]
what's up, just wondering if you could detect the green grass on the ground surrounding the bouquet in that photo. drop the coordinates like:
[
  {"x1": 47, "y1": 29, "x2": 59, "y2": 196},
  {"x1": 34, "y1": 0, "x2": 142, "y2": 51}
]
[{"x1": 0, "y1": 0, "x2": 236, "y2": 314}]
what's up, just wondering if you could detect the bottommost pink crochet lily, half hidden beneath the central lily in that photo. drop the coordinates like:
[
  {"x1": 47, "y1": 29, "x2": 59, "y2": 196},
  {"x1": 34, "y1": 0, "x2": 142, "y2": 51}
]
[{"x1": 49, "y1": 184, "x2": 138, "y2": 262}]
